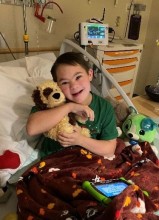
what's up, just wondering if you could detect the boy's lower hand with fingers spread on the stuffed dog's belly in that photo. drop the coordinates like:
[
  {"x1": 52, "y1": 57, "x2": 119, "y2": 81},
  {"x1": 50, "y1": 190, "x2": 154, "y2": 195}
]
[{"x1": 57, "y1": 127, "x2": 83, "y2": 147}]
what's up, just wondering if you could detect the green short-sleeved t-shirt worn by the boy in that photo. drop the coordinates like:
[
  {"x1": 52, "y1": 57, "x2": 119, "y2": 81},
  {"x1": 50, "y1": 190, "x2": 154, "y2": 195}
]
[{"x1": 31, "y1": 93, "x2": 118, "y2": 157}]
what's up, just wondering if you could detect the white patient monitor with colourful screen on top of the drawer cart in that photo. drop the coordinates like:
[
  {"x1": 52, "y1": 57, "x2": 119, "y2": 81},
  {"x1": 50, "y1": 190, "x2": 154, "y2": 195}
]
[{"x1": 79, "y1": 22, "x2": 108, "y2": 46}]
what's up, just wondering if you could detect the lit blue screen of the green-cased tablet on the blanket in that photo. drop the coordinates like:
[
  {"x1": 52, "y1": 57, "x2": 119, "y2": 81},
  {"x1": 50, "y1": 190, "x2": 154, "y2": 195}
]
[{"x1": 95, "y1": 181, "x2": 128, "y2": 197}]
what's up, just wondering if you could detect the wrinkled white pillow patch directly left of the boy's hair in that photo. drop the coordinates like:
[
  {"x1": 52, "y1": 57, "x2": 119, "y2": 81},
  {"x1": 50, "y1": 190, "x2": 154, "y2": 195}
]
[{"x1": 25, "y1": 56, "x2": 56, "y2": 79}]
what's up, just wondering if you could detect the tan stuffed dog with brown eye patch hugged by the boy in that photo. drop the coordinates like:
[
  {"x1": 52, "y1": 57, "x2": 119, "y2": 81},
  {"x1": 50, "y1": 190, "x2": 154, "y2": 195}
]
[{"x1": 32, "y1": 80, "x2": 90, "y2": 140}]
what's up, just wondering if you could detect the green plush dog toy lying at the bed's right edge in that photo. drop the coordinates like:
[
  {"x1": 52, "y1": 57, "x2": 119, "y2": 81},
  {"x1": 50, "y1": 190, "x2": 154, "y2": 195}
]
[{"x1": 122, "y1": 109, "x2": 158, "y2": 155}]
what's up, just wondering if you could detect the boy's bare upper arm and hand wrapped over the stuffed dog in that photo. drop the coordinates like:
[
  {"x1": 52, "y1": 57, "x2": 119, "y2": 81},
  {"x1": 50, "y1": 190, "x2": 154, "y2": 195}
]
[{"x1": 26, "y1": 102, "x2": 94, "y2": 136}]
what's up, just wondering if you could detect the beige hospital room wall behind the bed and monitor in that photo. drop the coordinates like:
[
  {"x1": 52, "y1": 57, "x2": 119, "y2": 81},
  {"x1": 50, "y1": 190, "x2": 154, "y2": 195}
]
[{"x1": 0, "y1": 0, "x2": 153, "y2": 94}]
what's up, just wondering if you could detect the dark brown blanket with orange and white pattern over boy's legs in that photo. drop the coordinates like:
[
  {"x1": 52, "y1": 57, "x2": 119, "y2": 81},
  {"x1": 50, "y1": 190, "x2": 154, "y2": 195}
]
[{"x1": 17, "y1": 140, "x2": 159, "y2": 220}]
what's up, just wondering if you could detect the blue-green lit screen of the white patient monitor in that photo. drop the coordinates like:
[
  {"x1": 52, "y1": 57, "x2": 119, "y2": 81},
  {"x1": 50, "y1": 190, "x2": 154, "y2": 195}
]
[{"x1": 87, "y1": 25, "x2": 105, "y2": 39}]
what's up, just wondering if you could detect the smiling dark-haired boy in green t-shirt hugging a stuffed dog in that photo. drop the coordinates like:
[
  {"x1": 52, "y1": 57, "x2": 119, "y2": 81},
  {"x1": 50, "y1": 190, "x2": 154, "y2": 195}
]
[{"x1": 27, "y1": 52, "x2": 118, "y2": 157}]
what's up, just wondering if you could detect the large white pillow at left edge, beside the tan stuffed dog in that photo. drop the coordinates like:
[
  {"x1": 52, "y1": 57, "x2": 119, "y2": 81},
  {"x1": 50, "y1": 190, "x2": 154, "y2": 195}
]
[{"x1": 0, "y1": 66, "x2": 34, "y2": 141}]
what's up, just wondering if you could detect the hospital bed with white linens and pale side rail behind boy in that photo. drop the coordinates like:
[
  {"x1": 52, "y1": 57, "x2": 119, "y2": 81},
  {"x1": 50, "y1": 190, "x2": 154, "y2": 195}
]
[{"x1": 0, "y1": 39, "x2": 158, "y2": 219}]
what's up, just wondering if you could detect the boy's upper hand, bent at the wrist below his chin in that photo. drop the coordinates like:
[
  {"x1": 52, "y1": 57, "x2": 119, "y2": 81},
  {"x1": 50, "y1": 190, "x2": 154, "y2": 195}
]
[{"x1": 69, "y1": 103, "x2": 94, "y2": 121}]
